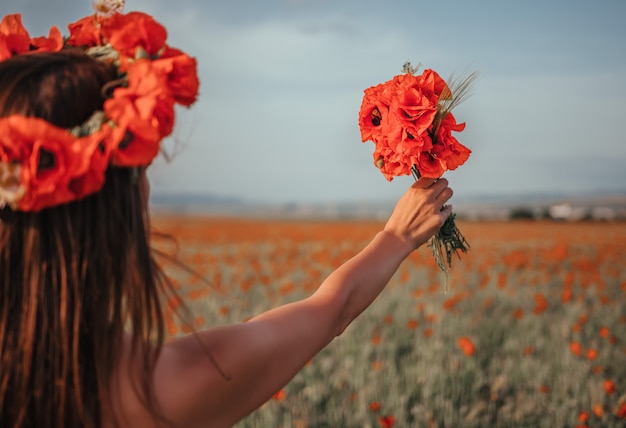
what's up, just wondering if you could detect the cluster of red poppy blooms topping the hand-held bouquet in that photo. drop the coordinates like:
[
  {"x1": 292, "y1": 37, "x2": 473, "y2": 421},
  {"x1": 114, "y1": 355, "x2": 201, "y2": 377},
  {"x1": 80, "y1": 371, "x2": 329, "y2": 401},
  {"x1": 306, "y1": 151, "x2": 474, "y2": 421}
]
[{"x1": 359, "y1": 70, "x2": 471, "y2": 181}]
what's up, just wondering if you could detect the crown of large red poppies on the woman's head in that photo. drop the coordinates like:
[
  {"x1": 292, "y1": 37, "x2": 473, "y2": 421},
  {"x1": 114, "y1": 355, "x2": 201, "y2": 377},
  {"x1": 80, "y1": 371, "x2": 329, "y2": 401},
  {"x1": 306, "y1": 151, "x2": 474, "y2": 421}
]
[{"x1": 0, "y1": 3, "x2": 199, "y2": 211}]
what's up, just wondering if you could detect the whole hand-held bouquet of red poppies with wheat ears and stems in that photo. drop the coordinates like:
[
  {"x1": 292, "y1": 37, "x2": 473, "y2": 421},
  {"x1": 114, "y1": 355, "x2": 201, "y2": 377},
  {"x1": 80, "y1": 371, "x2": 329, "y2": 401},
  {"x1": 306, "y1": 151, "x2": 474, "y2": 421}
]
[{"x1": 359, "y1": 62, "x2": 477, "y2": 284}]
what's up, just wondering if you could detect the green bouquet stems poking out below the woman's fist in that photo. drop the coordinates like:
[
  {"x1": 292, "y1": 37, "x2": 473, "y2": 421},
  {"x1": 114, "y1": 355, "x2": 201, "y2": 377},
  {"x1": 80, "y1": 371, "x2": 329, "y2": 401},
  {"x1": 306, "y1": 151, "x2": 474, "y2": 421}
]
[{"x1": 411, "y1": 165, "x2": 470, "y2": 293}]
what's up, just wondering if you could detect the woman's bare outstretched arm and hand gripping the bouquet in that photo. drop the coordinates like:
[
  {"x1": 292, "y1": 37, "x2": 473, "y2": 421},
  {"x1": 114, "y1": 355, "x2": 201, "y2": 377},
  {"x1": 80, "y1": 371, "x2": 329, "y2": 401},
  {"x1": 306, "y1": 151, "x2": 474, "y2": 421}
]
[{"x1": 150, "y1": 179, "x2": 452, "y2": 427}]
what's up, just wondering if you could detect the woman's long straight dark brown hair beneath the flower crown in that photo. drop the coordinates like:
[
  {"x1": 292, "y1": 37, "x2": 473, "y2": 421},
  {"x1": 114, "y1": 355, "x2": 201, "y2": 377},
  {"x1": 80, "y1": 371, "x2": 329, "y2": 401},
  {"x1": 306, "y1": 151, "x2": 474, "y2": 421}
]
[{"x1": 0, "y1": 52, "x2": 166, "y2": 428}]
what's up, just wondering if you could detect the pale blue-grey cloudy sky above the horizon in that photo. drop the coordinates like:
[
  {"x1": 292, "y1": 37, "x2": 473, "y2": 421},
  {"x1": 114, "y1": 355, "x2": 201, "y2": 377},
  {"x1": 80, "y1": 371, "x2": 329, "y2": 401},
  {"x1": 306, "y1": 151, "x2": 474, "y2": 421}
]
[{"x1": 0, "y1": 0, "x2": 626, "y2": 203}]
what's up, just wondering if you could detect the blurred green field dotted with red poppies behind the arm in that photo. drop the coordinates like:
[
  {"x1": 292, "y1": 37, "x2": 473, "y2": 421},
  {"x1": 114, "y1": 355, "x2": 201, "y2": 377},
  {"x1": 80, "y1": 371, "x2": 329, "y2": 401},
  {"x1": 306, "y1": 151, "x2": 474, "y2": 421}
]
[{"x1": 153, "y1": 216, "x2": 626, "y2": 428}]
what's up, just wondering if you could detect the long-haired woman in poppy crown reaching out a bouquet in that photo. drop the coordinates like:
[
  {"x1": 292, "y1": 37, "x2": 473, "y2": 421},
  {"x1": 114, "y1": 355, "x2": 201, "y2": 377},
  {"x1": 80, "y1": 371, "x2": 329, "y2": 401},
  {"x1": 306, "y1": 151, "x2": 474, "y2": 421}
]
[{"x1": 0, "y1": 7, "x2": 452, "y2": 428}]
